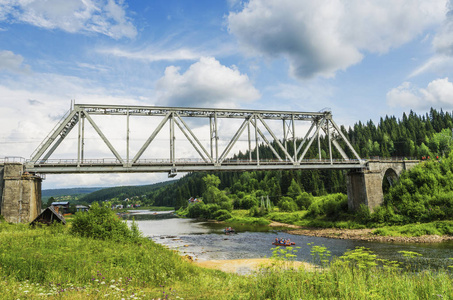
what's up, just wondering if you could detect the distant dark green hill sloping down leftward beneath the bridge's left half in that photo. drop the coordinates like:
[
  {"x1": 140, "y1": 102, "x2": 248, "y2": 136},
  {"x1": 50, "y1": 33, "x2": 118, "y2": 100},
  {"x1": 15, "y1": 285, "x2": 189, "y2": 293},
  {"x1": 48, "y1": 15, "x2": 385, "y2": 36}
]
[{"x1": 79, "y1": 180, "x2": 176, "y2": 203}]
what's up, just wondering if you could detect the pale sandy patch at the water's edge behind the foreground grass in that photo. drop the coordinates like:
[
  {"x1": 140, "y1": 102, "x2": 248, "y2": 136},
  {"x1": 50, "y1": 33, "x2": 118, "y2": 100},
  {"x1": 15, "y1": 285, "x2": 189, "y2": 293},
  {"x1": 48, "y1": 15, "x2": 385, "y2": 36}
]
[{"x1": 194, "y1": 258, "x2": 314, "y2": 275}]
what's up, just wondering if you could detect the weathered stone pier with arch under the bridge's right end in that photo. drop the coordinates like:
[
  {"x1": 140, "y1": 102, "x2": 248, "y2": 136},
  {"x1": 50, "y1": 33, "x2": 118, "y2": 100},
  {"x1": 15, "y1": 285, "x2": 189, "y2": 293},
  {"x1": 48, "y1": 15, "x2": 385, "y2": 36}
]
[{"x1": 347, "y1": 160, "x2": 420, "y2": 212}]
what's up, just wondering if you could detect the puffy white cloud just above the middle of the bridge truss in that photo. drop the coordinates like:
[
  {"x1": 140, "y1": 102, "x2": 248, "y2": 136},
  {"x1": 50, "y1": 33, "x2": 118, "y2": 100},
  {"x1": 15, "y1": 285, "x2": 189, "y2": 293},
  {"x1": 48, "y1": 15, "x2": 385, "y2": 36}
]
[{"x1": 156, "y1": 57, "x2": 260, "y2": 108}]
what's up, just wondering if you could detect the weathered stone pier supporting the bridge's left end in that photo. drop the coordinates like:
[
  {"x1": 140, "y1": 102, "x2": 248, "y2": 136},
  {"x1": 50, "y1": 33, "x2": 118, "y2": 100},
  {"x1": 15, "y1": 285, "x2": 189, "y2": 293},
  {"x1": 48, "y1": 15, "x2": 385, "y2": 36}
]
[{"x1": 0, "y1": 162, "x2": 42, "y2": 223}]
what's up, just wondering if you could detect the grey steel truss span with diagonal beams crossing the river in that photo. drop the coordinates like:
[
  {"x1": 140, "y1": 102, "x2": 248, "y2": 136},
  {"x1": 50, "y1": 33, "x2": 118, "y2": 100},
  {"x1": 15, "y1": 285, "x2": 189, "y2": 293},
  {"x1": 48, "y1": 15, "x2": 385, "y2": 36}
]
[{"x1": 25, "y1": 104, "x2": 366, "y2": 177}]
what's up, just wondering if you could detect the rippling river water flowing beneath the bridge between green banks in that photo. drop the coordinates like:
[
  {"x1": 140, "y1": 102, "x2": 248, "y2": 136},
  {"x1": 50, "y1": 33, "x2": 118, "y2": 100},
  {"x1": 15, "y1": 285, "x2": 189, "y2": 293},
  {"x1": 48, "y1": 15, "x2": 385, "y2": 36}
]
[{"x1": 126, "y1": 211, "x2": 453, "y2": 269}]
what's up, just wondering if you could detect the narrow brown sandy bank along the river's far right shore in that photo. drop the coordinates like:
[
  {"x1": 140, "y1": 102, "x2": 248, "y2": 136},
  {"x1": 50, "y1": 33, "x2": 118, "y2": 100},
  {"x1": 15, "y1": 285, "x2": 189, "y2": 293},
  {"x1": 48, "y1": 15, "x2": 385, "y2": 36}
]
[{"x1": 269, "y1": 222, "x2": 453, "y2": 243}]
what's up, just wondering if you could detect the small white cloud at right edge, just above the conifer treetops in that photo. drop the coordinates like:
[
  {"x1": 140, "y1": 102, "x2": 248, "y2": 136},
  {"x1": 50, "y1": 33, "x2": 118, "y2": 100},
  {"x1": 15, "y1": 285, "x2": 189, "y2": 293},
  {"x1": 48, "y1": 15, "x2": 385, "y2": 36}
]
[{"x1": 387, "y1": 77, "x2": 453, "y2": 109}]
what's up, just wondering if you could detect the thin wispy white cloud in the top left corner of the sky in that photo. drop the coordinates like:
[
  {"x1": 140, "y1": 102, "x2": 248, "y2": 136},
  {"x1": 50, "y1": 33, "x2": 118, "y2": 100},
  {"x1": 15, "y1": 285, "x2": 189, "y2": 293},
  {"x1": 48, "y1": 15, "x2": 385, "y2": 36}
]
[{"x1": 0, "y1": 0, "x2": 137, "y2": 39}]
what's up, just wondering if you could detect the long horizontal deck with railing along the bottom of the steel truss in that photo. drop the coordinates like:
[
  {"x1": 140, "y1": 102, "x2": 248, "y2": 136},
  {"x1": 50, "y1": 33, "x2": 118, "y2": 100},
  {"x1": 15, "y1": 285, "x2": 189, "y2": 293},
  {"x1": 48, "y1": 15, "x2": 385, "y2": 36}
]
[{"x1": 25, "y1": 159, "x2": 366, "y2": 174}]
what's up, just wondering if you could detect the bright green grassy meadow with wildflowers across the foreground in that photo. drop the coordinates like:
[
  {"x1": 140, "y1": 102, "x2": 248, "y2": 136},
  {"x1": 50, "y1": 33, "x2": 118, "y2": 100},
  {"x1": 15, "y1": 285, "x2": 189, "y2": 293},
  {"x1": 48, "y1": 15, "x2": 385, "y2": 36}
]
[{"x1": 0, "y1": 223, "x2": 453, "y2": 299}]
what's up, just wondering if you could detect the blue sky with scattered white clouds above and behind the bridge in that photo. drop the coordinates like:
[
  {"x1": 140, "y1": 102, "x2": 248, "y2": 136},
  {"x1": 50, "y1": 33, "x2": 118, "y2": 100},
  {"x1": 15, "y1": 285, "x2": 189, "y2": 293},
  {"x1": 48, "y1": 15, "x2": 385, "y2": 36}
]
[{"x1": 0, "y1": 0, "x2": 453, "y2": 187}]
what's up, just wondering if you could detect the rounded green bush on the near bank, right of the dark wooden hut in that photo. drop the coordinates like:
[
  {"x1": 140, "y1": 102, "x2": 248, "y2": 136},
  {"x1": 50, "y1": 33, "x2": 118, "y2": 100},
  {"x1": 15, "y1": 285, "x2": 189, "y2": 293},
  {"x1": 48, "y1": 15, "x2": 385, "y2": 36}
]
[{"x1": 70, "y1": 202, "x2": 141, "y2": 241}]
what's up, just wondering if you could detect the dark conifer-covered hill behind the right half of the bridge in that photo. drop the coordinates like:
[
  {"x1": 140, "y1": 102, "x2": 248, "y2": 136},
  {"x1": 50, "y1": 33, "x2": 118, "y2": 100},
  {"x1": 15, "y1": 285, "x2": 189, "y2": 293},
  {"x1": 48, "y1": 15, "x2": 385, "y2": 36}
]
[{"x1": 143, "y1": 109, "x2": 453, "y2": 208}]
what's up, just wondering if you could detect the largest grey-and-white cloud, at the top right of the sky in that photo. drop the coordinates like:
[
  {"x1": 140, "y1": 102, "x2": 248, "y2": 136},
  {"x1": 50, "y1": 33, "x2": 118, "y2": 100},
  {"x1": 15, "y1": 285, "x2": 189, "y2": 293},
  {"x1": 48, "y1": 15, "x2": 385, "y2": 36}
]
[{"x1": 228, "y1": 0, "x2": 446, "y2": 78}]
